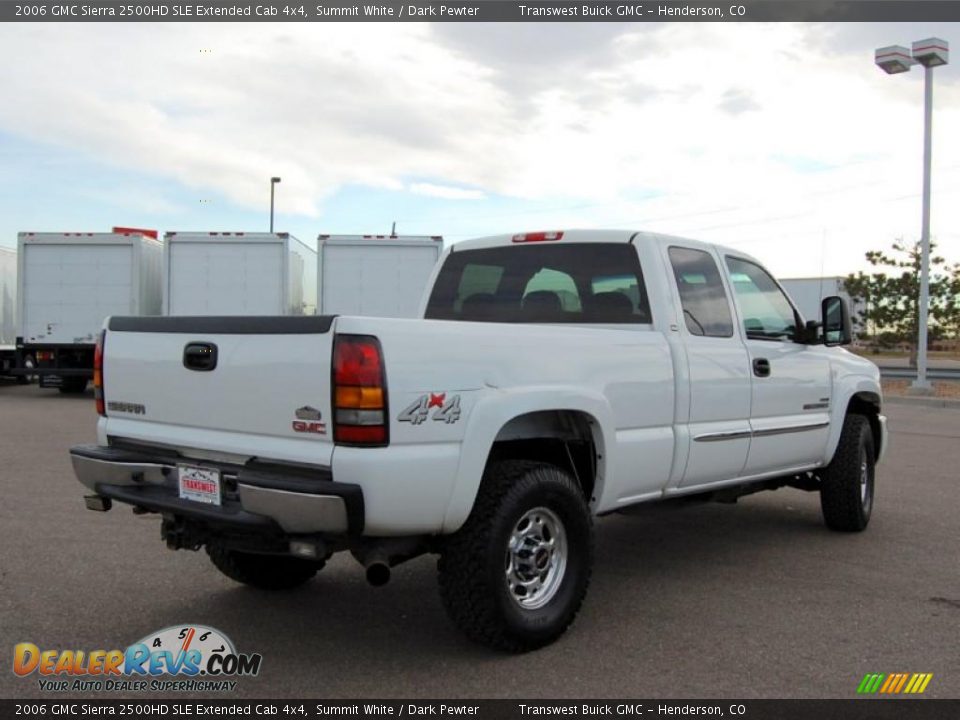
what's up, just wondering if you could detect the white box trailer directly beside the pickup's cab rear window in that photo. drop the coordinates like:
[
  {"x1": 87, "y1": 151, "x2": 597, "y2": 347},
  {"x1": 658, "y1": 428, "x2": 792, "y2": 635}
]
[{"x1": 317, "y1": 235, "x2": 443, "y2": 318}]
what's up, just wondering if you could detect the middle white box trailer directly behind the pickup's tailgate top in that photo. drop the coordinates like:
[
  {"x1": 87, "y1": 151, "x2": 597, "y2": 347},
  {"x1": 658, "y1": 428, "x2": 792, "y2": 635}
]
[{"x1": 163, "y1": 232, "x2": 317, "y2": 315}]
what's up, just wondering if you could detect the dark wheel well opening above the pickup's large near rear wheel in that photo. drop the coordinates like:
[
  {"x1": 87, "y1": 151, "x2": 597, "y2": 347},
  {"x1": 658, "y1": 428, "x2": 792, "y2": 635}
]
[{"x1": 487, "y1": 410, "x2": 599, "y2": 502}]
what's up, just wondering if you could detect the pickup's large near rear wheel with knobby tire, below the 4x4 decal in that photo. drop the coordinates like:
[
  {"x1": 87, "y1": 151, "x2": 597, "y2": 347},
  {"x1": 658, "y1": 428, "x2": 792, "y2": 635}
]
[{"x1": 439, "y1": 460, "x2": 593, "y2": 652}]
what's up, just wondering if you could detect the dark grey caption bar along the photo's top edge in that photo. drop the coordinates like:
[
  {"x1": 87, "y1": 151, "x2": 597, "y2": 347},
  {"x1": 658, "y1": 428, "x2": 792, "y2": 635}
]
[{"x1": 0, "y1": 0, "x2": 960, "y2": 22}]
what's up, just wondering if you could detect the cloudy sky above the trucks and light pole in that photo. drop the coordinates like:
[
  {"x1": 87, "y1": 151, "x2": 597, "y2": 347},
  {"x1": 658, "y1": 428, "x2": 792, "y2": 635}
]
[{"x1": 0, "y1": 22, "x2": 960, "y2": 277}]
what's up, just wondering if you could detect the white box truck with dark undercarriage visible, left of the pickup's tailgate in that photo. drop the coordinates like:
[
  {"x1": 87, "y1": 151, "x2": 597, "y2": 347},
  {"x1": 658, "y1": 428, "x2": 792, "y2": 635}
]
[{"x1": 14, "y1": 228, "x2": 162, "y2": 393}]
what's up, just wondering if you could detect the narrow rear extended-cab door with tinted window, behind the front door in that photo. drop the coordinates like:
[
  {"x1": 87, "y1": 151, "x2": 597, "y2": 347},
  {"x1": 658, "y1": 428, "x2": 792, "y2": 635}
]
[{"x1": 667, "y1": 246, "x2": 750, "y2": 487}]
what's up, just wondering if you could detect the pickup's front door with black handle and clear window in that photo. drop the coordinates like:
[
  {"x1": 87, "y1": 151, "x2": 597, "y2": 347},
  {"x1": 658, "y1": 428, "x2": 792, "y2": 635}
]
[{"x1": 725, "y1": 255, "x2": 831, "y2": 475}]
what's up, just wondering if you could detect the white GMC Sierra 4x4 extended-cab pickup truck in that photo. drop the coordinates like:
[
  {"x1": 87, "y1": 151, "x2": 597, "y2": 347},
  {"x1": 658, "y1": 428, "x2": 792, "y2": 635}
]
[{"x1": 71, "y1": 230, "x2": 887, "y2": 651}]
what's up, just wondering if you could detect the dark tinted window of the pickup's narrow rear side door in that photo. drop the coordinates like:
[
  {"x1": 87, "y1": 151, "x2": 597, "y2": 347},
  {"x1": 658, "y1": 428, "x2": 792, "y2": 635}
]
[{"x1": 669, "y1": 247, "x2": 733, "y2": 337}]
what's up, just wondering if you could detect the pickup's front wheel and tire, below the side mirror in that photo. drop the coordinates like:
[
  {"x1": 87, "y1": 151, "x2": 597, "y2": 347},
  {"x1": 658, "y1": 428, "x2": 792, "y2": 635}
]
[{"x1": 820, "y1": 414, "x2": 876, "y2": 532}]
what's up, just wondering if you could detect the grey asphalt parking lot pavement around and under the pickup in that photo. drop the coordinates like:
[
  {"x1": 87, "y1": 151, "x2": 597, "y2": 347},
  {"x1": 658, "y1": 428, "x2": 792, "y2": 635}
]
[{"x1": 0, "y1": 384, "x2": 960, "y2": 699}]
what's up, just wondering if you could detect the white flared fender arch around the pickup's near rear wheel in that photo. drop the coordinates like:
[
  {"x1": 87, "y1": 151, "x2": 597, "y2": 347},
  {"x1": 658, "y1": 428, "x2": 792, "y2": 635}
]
[{"x1": 442, "y1": 387, "x2": 615, "y2": 534}]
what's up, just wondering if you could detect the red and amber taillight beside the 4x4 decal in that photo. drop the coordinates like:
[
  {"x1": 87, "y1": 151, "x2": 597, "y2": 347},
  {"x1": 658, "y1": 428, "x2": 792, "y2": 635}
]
[{"x1": 332, "y1": 335, "x2": 389, "y2": 445}]
